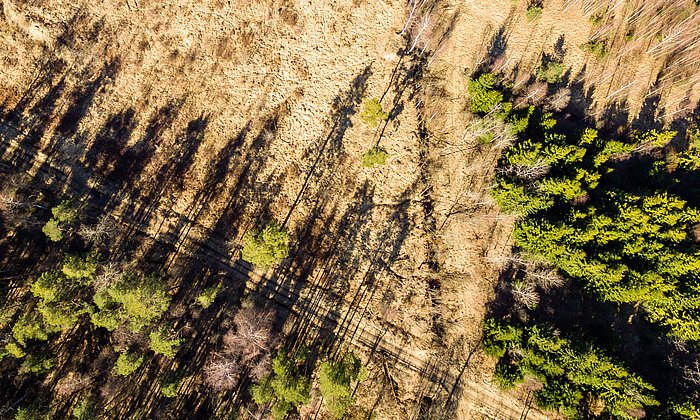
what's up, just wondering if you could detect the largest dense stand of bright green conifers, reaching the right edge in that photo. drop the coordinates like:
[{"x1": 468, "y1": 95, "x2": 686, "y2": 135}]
[{"x1": 493, "y1": 114, "x2": 700, "y2": 341}]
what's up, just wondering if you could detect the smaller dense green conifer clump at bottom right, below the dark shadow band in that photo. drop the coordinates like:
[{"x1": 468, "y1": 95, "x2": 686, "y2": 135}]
[{"x1": 484, "y1": 318, "x2": 658, "y2": 418}]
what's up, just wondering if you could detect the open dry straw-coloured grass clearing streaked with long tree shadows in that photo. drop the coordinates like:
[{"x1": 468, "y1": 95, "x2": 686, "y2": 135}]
[{"x1": 0, "y1": 0, "x2": 688, "y2": 419}]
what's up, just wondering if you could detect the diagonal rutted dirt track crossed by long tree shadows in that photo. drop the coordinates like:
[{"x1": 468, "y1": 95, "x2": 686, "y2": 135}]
[{"x1": 0, "y1": 123, "x2": 547, "y2": 419}]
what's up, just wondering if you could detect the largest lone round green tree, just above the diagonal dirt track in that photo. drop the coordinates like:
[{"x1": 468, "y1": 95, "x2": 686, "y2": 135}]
[{"x1": 241, "y1": 221, "x2": 289, "y2": 268}]
